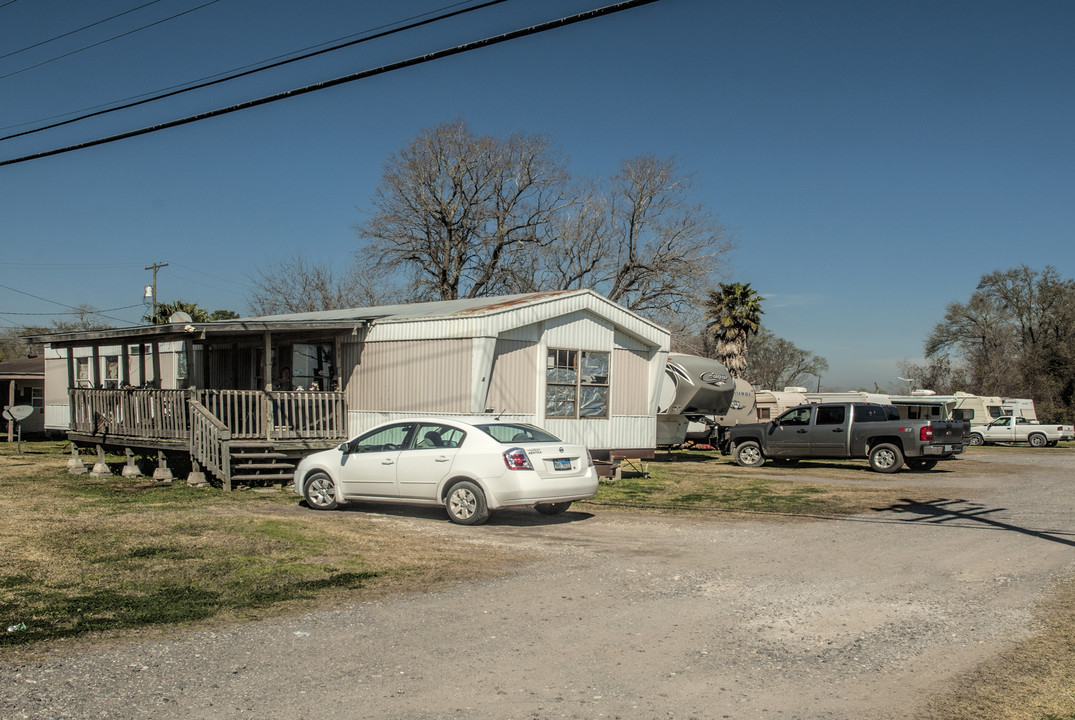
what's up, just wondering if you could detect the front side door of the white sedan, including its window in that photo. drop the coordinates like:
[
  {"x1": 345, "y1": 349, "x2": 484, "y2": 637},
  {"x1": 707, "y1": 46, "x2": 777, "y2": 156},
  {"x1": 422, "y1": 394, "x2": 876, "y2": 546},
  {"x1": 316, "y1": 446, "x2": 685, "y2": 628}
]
[{"x1": 340, "y1": 422, "x2": 414, "y2": 498}]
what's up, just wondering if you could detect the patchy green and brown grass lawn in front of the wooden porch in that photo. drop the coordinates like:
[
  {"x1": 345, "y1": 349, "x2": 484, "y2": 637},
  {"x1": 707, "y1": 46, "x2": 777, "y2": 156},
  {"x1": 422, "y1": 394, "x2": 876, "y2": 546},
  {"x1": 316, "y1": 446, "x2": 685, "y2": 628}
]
[{"x1": 0, "y1": 442, "x2": 518, "y2": 652}]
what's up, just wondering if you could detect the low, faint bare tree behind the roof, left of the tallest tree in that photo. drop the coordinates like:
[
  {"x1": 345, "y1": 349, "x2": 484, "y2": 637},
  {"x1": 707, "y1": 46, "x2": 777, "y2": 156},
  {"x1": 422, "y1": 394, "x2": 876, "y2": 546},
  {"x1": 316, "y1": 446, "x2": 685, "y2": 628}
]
[{"x1": 248, "y1": 255, "x2": 402, "y2": 315}]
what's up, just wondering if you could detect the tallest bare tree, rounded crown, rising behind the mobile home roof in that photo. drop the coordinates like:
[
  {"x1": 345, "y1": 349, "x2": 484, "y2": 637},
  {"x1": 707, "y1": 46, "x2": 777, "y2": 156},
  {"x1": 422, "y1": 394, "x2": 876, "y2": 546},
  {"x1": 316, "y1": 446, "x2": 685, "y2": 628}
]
[{"x1": 358, "y1": 120, "x2": 568, "y2": 300}]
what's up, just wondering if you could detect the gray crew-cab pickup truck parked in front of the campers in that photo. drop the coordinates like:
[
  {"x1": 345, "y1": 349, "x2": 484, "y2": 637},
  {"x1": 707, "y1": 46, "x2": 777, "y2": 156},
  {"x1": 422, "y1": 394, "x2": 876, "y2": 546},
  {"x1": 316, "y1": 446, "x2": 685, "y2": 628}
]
[{"x1": 723, "y1": 403, "x2": 966, "y2": 473}]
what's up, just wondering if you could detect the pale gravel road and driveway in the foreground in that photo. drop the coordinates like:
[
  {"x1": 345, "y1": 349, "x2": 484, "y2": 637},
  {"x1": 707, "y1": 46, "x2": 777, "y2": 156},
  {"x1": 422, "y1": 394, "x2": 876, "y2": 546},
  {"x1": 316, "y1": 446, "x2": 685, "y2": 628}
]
[{"x1": 0, "y1": 449, "x2": 1075, "y2": 720}]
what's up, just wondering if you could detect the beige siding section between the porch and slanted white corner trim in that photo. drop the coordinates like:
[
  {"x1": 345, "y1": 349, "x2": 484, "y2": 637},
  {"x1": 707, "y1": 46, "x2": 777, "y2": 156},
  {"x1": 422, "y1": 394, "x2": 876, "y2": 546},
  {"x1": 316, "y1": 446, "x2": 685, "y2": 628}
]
[{"x1": 348, "y1": 340, "x2": 471, "y2": 413}]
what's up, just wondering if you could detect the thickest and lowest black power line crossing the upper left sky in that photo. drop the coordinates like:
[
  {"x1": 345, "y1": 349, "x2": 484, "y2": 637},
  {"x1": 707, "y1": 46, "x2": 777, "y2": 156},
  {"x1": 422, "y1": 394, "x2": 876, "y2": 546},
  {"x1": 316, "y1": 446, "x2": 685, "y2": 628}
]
[{"x1": 0, "y1": 0, "x2": 658, "y2": 168}]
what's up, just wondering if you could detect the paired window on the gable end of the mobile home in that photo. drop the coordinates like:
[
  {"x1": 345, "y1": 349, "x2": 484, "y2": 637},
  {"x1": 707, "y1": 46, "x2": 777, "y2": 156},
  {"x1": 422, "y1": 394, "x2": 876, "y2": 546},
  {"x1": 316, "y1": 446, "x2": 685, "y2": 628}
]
[{"x1": 545, "y1": 348, "x2": 608, "y2": 418}]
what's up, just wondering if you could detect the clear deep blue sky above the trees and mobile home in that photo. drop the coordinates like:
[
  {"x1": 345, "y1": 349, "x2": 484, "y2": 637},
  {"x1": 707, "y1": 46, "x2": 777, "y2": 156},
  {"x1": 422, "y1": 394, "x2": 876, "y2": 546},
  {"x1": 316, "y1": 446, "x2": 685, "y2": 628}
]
[{"x1": 0, "y1": 0, "x2": 1075, "y2": 390}]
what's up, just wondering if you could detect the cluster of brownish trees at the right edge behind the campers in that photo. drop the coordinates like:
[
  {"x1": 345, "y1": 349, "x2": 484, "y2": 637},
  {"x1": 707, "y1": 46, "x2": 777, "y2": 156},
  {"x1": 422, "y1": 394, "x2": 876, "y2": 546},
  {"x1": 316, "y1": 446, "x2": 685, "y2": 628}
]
[{"x1": 900, "y1": 265, "x2": 1075, "y2": 421}]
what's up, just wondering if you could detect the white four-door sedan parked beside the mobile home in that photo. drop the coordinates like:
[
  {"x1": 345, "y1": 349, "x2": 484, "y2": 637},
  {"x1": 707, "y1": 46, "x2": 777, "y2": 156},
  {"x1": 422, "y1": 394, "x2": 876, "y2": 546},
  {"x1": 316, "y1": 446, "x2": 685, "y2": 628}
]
[{"x1": 295, "y1": 418, "x2": 598, "y2": 524}]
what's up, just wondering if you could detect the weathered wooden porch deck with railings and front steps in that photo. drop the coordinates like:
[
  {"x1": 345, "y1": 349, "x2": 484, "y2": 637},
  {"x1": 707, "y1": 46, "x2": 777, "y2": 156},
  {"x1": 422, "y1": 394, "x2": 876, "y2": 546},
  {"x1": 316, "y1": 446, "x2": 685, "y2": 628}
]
[{"x1": 68, "y1": 388, "x2": 347, "y2": 490}]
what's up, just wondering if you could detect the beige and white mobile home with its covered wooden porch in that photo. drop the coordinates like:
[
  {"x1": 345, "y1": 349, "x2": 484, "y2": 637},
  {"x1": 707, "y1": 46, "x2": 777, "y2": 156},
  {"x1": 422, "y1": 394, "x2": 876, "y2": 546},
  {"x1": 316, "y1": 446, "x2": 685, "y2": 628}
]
[{"x1": 32, "y1": 290, "x2": 670, "y2": 487}]
